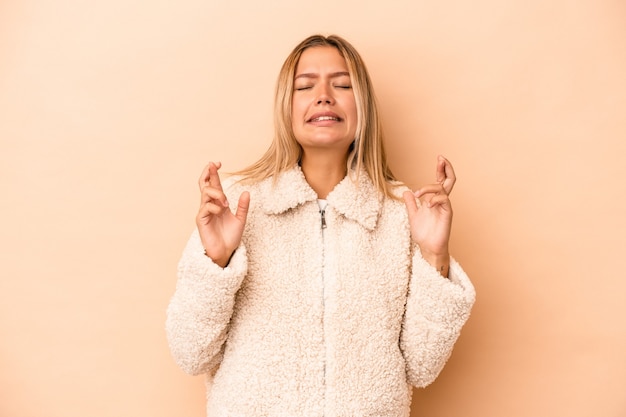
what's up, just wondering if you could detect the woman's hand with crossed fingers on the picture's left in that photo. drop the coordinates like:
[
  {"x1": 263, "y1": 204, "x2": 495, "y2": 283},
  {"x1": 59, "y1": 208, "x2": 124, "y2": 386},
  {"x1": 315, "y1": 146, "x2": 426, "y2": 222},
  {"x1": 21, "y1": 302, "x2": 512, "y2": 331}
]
[{"x1": 196, "y1": 162, "x2": 250, "y2": 268}]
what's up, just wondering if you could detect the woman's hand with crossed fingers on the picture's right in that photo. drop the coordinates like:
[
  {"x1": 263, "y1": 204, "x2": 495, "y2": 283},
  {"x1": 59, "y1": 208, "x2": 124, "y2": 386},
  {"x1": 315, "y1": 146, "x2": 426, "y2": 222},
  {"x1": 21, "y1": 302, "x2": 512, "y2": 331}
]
[{"x1": 403, "y1": 156, "x2": 456, "y2": 276}]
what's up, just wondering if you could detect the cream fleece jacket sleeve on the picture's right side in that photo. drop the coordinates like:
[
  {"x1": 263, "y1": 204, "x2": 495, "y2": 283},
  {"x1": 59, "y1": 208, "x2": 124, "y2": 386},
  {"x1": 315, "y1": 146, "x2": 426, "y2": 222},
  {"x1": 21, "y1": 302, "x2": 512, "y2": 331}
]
[{"x1": 400, "y1": 244, "x2": 476, "y2": 387}]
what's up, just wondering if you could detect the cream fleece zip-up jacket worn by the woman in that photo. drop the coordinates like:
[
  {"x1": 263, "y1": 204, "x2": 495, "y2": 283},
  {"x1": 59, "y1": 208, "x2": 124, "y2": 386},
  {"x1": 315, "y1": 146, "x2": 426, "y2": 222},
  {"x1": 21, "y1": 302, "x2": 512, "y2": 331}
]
[{"x1": 166, "y1": 167, "x2": 475, "y2": 417}]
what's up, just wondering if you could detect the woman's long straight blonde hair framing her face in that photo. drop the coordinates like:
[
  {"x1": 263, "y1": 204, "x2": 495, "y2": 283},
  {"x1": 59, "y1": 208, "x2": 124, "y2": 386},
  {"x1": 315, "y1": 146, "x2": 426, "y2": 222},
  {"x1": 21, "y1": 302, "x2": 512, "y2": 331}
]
[{"x1": 235, "y1": 35, "x2": 397, "y2": 198}]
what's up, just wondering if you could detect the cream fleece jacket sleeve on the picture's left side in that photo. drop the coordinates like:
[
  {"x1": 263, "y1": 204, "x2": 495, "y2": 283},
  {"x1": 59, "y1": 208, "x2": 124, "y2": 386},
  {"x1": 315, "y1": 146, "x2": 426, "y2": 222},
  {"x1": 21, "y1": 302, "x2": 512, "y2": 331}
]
[{"x1": 166, "y1": 231, "x2": 247, "y2": 375}]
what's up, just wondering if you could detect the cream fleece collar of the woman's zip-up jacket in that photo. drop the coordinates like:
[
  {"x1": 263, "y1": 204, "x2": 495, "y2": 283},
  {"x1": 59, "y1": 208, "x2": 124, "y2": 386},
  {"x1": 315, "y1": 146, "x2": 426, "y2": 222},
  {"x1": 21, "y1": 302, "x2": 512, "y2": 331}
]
[{"x1": 259, "y1": 166, "x2": 382, "y2": 230}]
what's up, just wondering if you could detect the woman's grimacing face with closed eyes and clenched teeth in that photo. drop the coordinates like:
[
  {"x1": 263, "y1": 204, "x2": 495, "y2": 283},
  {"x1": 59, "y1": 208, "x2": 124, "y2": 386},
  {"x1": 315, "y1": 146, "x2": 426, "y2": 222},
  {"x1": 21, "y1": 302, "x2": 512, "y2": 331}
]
[{"x1": 291, "y1": 46, "x2": 357, "y2": 153}]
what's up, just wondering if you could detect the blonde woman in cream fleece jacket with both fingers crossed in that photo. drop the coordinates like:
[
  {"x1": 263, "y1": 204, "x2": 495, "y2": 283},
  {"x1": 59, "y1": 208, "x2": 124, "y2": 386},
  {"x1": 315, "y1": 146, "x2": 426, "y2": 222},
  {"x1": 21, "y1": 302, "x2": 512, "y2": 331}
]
[{"x1": 167, "y1": 36, "x2": 475, "y2": 417}]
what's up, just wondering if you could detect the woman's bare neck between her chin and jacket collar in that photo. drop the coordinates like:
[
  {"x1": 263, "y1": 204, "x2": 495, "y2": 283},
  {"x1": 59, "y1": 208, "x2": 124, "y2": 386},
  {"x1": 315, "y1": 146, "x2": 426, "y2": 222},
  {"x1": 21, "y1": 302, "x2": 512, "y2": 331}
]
[{"x1": 300, "y1": 152, "x2": 346, "y2": 198}]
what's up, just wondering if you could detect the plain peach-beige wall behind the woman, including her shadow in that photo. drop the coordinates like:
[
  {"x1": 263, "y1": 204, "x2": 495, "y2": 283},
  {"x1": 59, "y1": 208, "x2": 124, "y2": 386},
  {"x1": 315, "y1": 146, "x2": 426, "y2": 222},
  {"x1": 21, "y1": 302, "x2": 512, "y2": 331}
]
[{"x1": 0, "y1": 0, "x2": 626, "y2": 417}]
